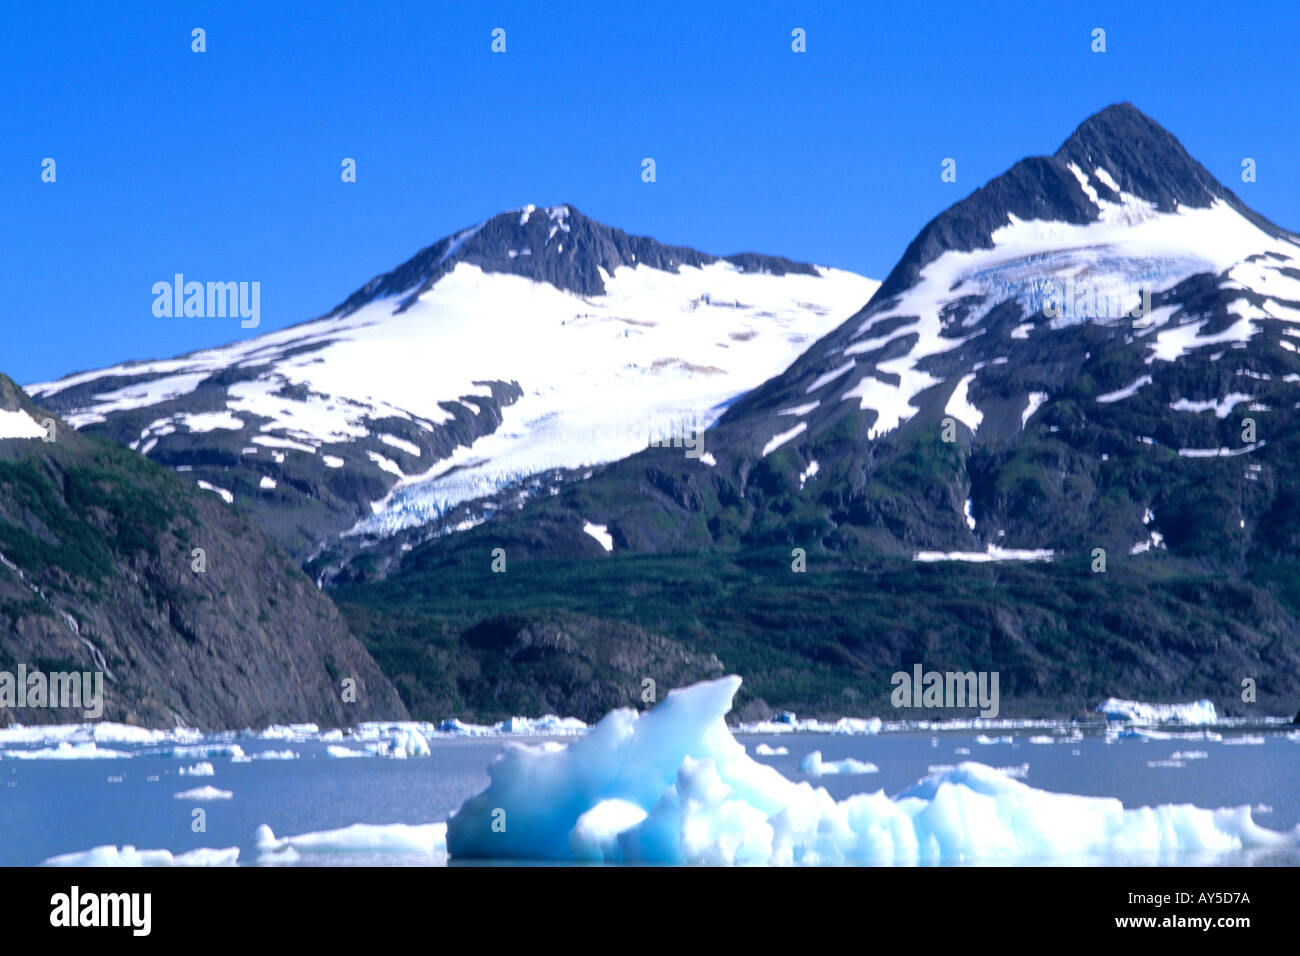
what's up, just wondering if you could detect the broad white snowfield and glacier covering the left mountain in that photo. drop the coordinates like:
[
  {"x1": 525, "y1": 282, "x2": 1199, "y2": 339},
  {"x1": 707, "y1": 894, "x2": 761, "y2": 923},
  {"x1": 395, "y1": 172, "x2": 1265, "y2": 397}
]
[{"x1": 30, "y1": 227, "x2": 880, "y2": 533}]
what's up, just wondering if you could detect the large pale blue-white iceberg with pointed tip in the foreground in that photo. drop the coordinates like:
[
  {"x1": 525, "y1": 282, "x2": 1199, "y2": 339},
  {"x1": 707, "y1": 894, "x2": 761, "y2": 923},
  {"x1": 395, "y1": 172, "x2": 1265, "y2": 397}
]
[{"x1": 446, "y1": 676, "x2": 1300, "y2": 864}]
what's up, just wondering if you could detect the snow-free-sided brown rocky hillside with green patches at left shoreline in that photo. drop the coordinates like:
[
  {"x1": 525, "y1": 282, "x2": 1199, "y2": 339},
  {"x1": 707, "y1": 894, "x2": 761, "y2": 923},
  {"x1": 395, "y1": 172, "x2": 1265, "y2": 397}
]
[{"x1": 0, "y1": 376, "x2": 407, "y2": 730}]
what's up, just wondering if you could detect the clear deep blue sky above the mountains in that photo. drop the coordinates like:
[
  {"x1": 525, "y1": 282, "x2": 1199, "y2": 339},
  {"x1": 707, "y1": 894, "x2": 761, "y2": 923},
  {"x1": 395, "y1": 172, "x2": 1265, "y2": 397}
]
[{"x1": 0, "y1": 0, "x2": 1300, "y2": 382}]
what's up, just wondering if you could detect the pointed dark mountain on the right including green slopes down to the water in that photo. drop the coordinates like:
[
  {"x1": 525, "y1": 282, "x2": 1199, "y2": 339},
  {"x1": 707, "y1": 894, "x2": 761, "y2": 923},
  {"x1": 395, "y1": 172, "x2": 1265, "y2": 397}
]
[{"x1": 337, "y1": 104, "x2": 1300, "y2": 713}]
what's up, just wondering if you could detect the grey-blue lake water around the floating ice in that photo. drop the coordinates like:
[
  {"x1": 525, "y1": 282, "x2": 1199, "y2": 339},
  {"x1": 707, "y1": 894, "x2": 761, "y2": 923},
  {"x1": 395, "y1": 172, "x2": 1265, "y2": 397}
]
[{"x1": 0, "y1": 728, "x2": 1300, "y2": 866}]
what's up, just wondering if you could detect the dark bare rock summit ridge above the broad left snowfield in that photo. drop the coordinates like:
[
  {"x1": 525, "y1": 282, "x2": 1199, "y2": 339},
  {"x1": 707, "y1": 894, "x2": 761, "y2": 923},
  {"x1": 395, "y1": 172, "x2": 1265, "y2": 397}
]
[{"x1": 330, "y1": 203, "x2": 816, "y2": 316}]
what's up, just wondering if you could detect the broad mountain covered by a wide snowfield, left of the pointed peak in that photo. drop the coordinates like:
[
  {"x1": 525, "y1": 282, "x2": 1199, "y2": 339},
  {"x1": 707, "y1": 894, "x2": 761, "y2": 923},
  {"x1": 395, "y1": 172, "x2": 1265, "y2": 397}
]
[{"x1": 29, "y1": 206, "x2": 879, "y2": 559}]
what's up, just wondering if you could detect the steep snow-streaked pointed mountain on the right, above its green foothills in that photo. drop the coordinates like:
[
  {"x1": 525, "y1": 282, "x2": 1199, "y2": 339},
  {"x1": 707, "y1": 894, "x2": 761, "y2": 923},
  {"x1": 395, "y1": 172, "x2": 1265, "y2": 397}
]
[{"x1": 423, "y1": 104, "x2": 1300, "y2": 561}]
